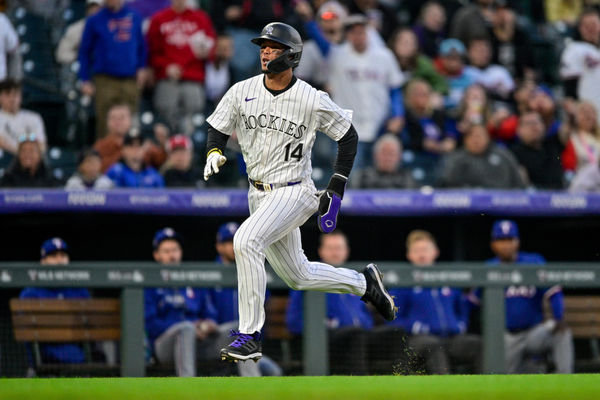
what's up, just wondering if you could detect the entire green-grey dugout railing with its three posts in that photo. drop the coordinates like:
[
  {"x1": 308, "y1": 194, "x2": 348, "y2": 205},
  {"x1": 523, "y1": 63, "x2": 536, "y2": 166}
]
[{"x1": 0, "y1": 262, "x2": 600, "y2": 377}]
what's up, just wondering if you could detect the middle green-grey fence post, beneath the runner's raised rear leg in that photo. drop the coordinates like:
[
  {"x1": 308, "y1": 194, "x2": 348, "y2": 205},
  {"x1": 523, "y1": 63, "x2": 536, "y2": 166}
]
[{"x1": 302, "y1": 291, "x2": 329, "y2": 375}]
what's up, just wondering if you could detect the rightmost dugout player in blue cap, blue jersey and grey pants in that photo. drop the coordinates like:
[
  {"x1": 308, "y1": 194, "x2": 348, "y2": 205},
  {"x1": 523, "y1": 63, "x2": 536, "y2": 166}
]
[{"x1": 469, "y1": 219, "x2": 574, "y2": 374}]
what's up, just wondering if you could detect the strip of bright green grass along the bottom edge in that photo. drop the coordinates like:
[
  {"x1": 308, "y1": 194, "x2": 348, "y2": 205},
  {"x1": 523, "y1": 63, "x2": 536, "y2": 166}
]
[{"x1": 0, "y1": 374, "x2": 600, "y2": 400}]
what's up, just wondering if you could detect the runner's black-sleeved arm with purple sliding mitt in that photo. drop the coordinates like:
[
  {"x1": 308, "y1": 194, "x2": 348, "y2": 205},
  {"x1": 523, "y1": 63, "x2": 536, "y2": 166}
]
[{"x1": 317, "y1": 125, "x2": 358, "y2": 233}]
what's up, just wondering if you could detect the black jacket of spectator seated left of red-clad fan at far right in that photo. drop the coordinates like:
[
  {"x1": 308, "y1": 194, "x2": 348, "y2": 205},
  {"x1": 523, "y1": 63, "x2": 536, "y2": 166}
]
[{"x1": 511, "y1": 135, "x2": 564, "y2": 189}]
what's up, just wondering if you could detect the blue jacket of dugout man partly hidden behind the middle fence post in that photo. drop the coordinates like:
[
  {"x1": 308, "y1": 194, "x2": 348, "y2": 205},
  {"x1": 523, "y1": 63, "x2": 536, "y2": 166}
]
[{"x1": 286, "y1": 290, "x2": 373, "y2": 334}]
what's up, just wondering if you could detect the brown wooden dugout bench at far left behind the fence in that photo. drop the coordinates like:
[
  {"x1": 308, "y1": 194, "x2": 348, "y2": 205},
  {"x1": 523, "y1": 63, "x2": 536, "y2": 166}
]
[{"x1": 10, "y1": 298, "x2": 236, "y2": 376}]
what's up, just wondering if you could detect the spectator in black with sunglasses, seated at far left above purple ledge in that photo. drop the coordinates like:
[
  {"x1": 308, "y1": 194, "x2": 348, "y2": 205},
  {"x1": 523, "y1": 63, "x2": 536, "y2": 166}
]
[{"x1": 0, "y1": 133, "x2": 59, "y2": 188}]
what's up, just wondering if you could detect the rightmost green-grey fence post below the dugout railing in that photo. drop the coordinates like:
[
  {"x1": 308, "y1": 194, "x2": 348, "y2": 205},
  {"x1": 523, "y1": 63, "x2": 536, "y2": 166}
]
[{"x1": 481, "y1": 287, "x2": 506, "y2": 374}]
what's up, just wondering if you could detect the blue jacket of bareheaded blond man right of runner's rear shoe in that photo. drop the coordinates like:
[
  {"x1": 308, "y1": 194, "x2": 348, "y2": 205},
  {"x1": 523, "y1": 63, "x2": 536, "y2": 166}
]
[{"x1": 389, "y1": 286, "x2": 468, "y2": 337}]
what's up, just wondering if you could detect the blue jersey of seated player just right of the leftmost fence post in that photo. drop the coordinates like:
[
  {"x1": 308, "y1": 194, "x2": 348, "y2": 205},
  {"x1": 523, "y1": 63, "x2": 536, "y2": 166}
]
[{"x1": 144, "y1": 287, "x2": 217, "y2": 342}]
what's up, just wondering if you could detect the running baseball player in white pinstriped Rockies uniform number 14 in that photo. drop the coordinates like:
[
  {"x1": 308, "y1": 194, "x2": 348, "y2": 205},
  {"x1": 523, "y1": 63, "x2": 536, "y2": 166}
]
[{"x1": 204, "y1": 22, "x2": 395, "y2": 362}]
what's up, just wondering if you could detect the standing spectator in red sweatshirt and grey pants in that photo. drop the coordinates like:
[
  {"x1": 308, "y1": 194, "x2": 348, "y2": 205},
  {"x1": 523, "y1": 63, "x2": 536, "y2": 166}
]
[{"x1": 148, "y1": 0, "x2": 216, "y2": 134}]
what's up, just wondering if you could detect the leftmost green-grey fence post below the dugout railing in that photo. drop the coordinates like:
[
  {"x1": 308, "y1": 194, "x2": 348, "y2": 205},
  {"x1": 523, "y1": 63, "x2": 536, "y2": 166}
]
[{"x1": 121, "y1": 288, "x2": 146, "y2": 377}]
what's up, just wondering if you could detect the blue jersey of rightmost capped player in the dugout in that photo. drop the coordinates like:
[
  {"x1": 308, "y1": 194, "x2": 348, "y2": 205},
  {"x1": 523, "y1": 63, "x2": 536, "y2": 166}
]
[{"x1": 470, "y1": 252, "x2": 564, "y2": 332}]
